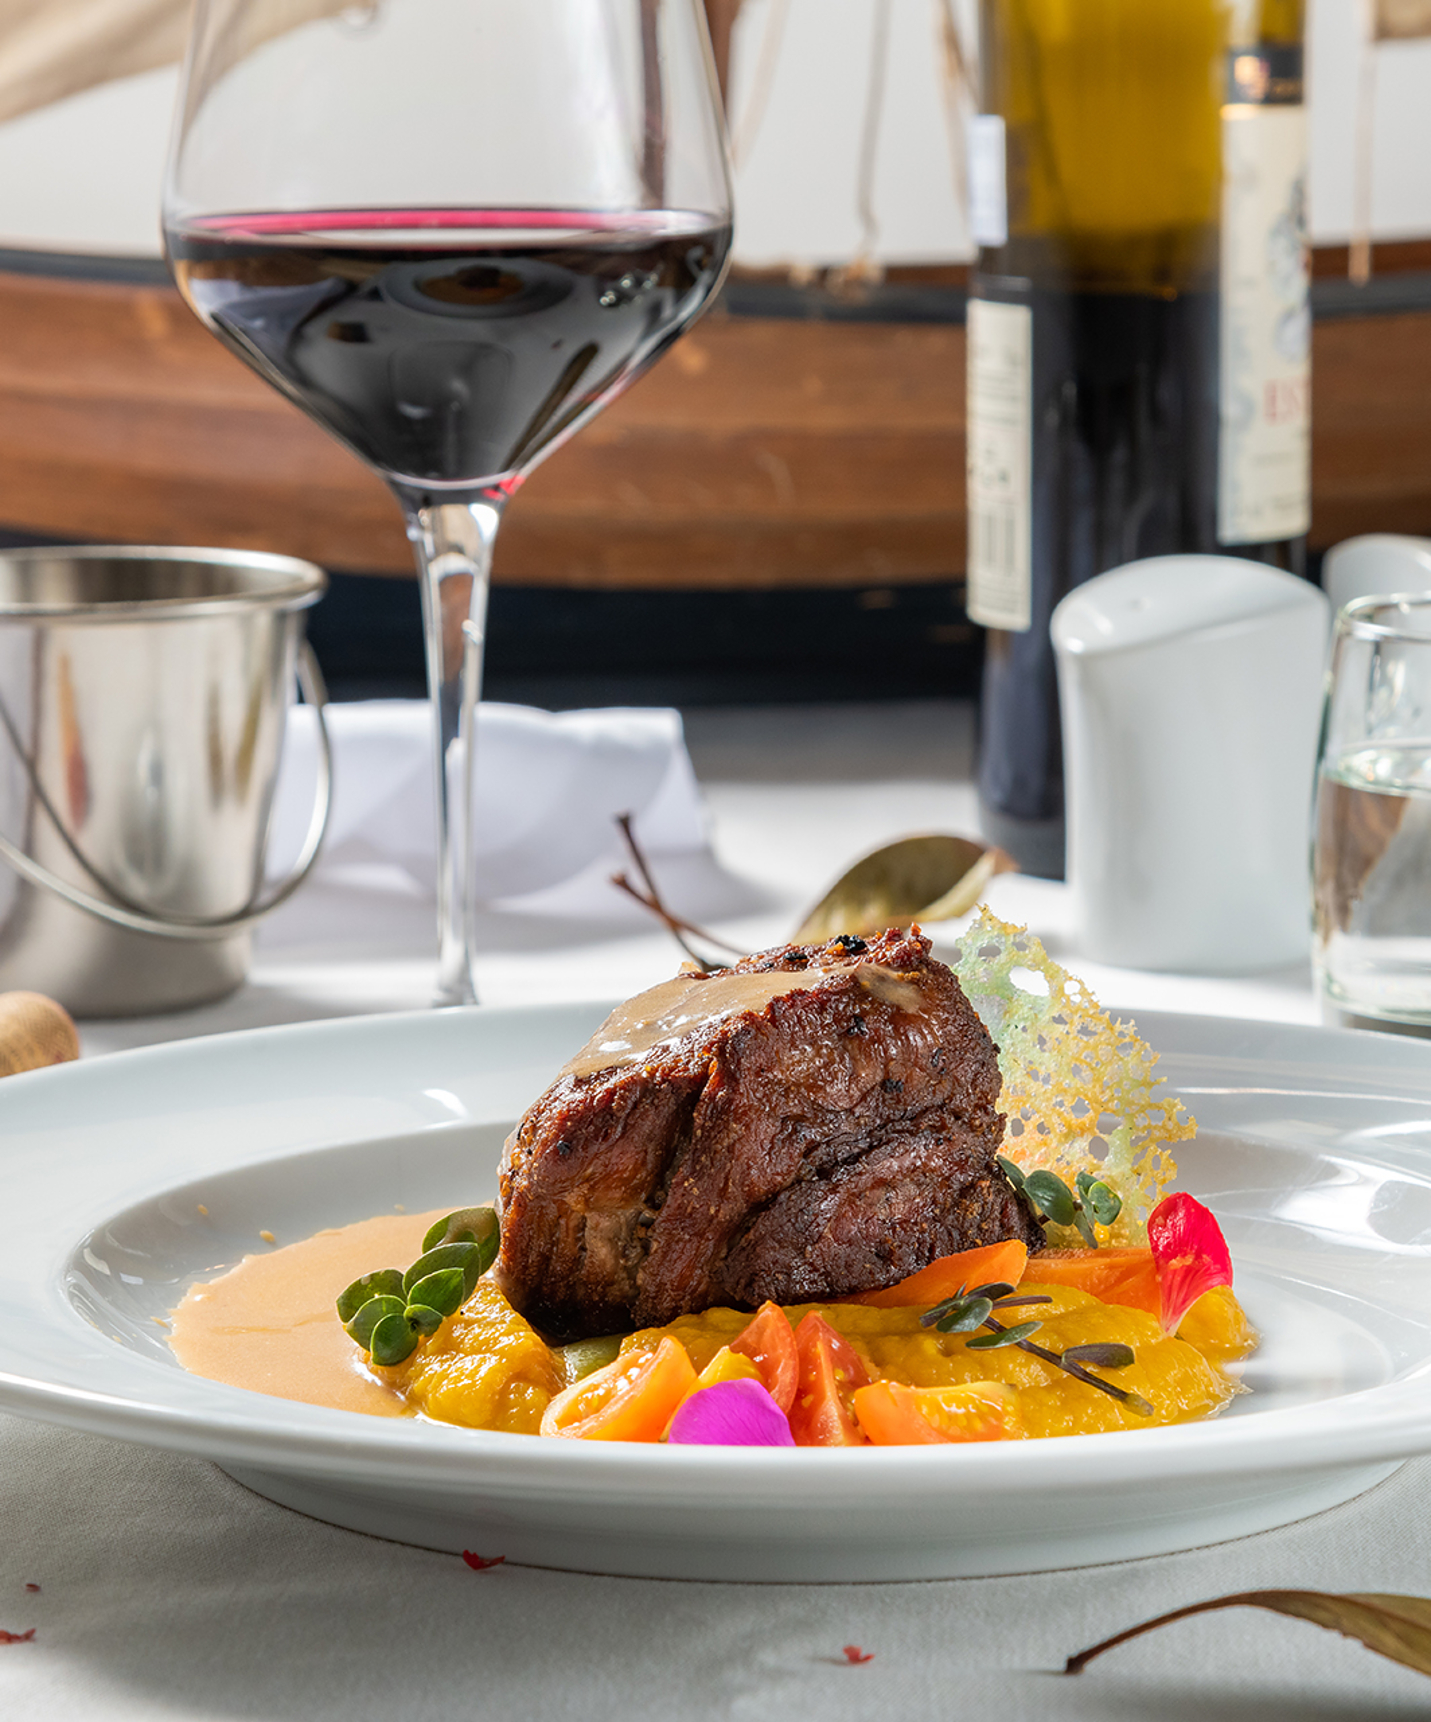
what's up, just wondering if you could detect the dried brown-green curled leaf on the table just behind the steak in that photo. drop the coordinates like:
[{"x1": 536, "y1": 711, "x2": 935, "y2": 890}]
[{"x1": 796, "y1": 832, "x2": 1014, "y2": 945}]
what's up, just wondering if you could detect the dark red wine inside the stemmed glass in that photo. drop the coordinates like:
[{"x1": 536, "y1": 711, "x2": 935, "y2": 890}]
[{"x1": 167, "y1": 208, "x2": 730, "y2": 489}]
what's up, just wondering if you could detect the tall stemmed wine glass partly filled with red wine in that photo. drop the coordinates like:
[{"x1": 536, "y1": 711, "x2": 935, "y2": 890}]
[{"x1": 164, "y1": 0, "x2": 730, "y2": 1004}]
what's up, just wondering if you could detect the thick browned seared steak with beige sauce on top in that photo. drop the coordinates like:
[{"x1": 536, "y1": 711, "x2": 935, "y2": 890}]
[{"x1": 498, "y1": 932, "x2": 1042, "y2": 1338}]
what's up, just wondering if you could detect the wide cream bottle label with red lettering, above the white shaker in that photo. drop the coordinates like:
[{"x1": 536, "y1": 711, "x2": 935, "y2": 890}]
[{"x1": 1217, "y1": 102, "x2": 1312, "y2": 544}]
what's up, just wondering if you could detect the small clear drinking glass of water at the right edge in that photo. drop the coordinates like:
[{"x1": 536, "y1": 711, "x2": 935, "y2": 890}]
[{"x1": 1312, "y1": 598, "x2": 1431, "y2": 1035}]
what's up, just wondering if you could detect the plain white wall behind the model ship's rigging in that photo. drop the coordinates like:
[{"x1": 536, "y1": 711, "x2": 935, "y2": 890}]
[{"x1": 0, "y1": 0, "x2": 1431, "y2": 263}]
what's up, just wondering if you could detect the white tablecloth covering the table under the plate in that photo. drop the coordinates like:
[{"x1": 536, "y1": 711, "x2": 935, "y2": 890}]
[{"x1": 0, "y1": 708, "x2": 1431, "y2": 1722}]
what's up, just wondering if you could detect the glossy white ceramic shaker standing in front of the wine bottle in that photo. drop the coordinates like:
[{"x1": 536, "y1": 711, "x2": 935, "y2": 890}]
[{"x1": 1052, "y1": 556, "x2": 1329, "y2": 975}]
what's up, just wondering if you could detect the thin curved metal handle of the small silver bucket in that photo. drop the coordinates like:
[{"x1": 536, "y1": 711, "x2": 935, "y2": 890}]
[{"x1": 0, "y1": 641, "x2": 332, "y2": 942}]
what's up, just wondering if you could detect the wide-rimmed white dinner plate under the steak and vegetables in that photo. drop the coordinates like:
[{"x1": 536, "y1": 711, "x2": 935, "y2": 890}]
[{"x1": 0, "y1": 1006, "x2": 1431, "y2": 1581}]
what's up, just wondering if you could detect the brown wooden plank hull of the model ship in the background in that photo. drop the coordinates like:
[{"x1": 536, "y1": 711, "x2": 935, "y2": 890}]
[{"x1": 0, "y1": 261, "x2": 1431, "y2": 587}]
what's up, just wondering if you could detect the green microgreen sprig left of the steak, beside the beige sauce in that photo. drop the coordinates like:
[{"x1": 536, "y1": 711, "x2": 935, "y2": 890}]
[{"x1": 338, "y1": 1207, "x2": 501, "y2": 1369}]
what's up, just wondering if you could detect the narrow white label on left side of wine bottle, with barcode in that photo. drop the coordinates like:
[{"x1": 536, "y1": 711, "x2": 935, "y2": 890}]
[{"x1": 966, "y1": 298, "x2": 1033, "y2": 634}]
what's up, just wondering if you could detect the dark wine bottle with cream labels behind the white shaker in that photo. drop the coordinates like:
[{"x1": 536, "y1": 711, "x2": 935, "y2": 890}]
[{"x1": 968, "y1": 0, "x2": 1310, "y2": 878}]
